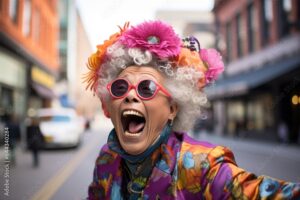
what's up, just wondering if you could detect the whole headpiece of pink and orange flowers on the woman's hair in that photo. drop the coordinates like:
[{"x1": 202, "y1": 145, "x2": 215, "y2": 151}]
[{"x1": 85, "y1": 21, "x2": 224, "y2": 92}]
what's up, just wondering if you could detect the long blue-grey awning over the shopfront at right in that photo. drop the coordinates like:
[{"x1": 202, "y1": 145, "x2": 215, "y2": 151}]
[{"x1": 205, "y1": 56, "x2": 300, "y2": 99}]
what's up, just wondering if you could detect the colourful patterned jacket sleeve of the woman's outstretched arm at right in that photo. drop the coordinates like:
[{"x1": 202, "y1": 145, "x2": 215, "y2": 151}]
[{"x1": 204, "y1": 146, "x2": 300, "y2": 199}]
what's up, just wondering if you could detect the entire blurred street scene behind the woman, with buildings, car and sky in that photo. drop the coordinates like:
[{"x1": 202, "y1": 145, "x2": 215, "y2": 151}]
[{"x1": 0, "y1": 0, "x2": 300, "y2": 200}]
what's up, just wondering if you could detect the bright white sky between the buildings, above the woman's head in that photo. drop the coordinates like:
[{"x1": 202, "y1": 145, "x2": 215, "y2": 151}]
[{"x1": 77, "y1": 0, "x2": 214, "y2": 48}]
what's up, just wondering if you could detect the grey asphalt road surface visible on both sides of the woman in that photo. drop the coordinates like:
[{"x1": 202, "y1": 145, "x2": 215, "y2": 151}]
[{"x1": 0, "y1": 127, "x2": 300, "y2": 200}]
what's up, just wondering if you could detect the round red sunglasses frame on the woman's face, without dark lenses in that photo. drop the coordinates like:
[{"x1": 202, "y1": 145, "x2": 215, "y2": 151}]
[{"x1": 106, "y1": 78, "x2": 171, "y2": 100}]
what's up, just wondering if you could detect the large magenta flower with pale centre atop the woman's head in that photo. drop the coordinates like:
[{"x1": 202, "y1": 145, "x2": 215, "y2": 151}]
[{"x1": 120, "y1": 21, "x2": 181, "y2": 58}]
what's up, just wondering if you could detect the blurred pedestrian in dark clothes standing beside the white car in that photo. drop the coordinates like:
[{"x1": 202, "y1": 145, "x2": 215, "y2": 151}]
[{"x1": 27, "y1": 117, "x2": 44, "y2": 167}]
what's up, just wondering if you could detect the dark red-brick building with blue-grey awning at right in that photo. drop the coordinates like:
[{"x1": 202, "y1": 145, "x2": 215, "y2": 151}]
[{"x1": 206, "y1": 0, "x2": 300, "y2": 142}]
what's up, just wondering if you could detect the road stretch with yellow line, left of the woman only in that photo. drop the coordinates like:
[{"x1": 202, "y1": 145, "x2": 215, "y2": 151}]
[{"x1": 0, "y1": 124, "x2": 110, "y2": 200}]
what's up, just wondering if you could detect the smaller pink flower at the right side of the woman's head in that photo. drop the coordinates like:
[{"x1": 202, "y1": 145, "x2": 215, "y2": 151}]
[{"x1": 200, "y1": 49, "x2": 224, "y2": 83}]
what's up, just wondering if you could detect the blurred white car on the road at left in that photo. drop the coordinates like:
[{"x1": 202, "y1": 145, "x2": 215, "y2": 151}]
[{"x1": 37, "y1": 108, "x2": 84, "y2": 148}]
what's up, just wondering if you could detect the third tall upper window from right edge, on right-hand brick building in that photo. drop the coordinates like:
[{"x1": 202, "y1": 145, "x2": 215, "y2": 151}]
[{"x1": 247, "y1": 3, "x2": 258, "y2": 53}]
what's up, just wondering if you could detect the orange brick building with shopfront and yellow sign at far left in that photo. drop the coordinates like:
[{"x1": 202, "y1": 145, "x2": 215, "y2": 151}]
[{"x1": 0, "y1": 0, "x2": 59, "y2": 144}]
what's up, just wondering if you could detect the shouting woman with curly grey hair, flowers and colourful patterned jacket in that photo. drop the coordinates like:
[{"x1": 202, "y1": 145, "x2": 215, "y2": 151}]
[{"x1": 86, "y1": 21, "x2": 300, "y2": 199}]
